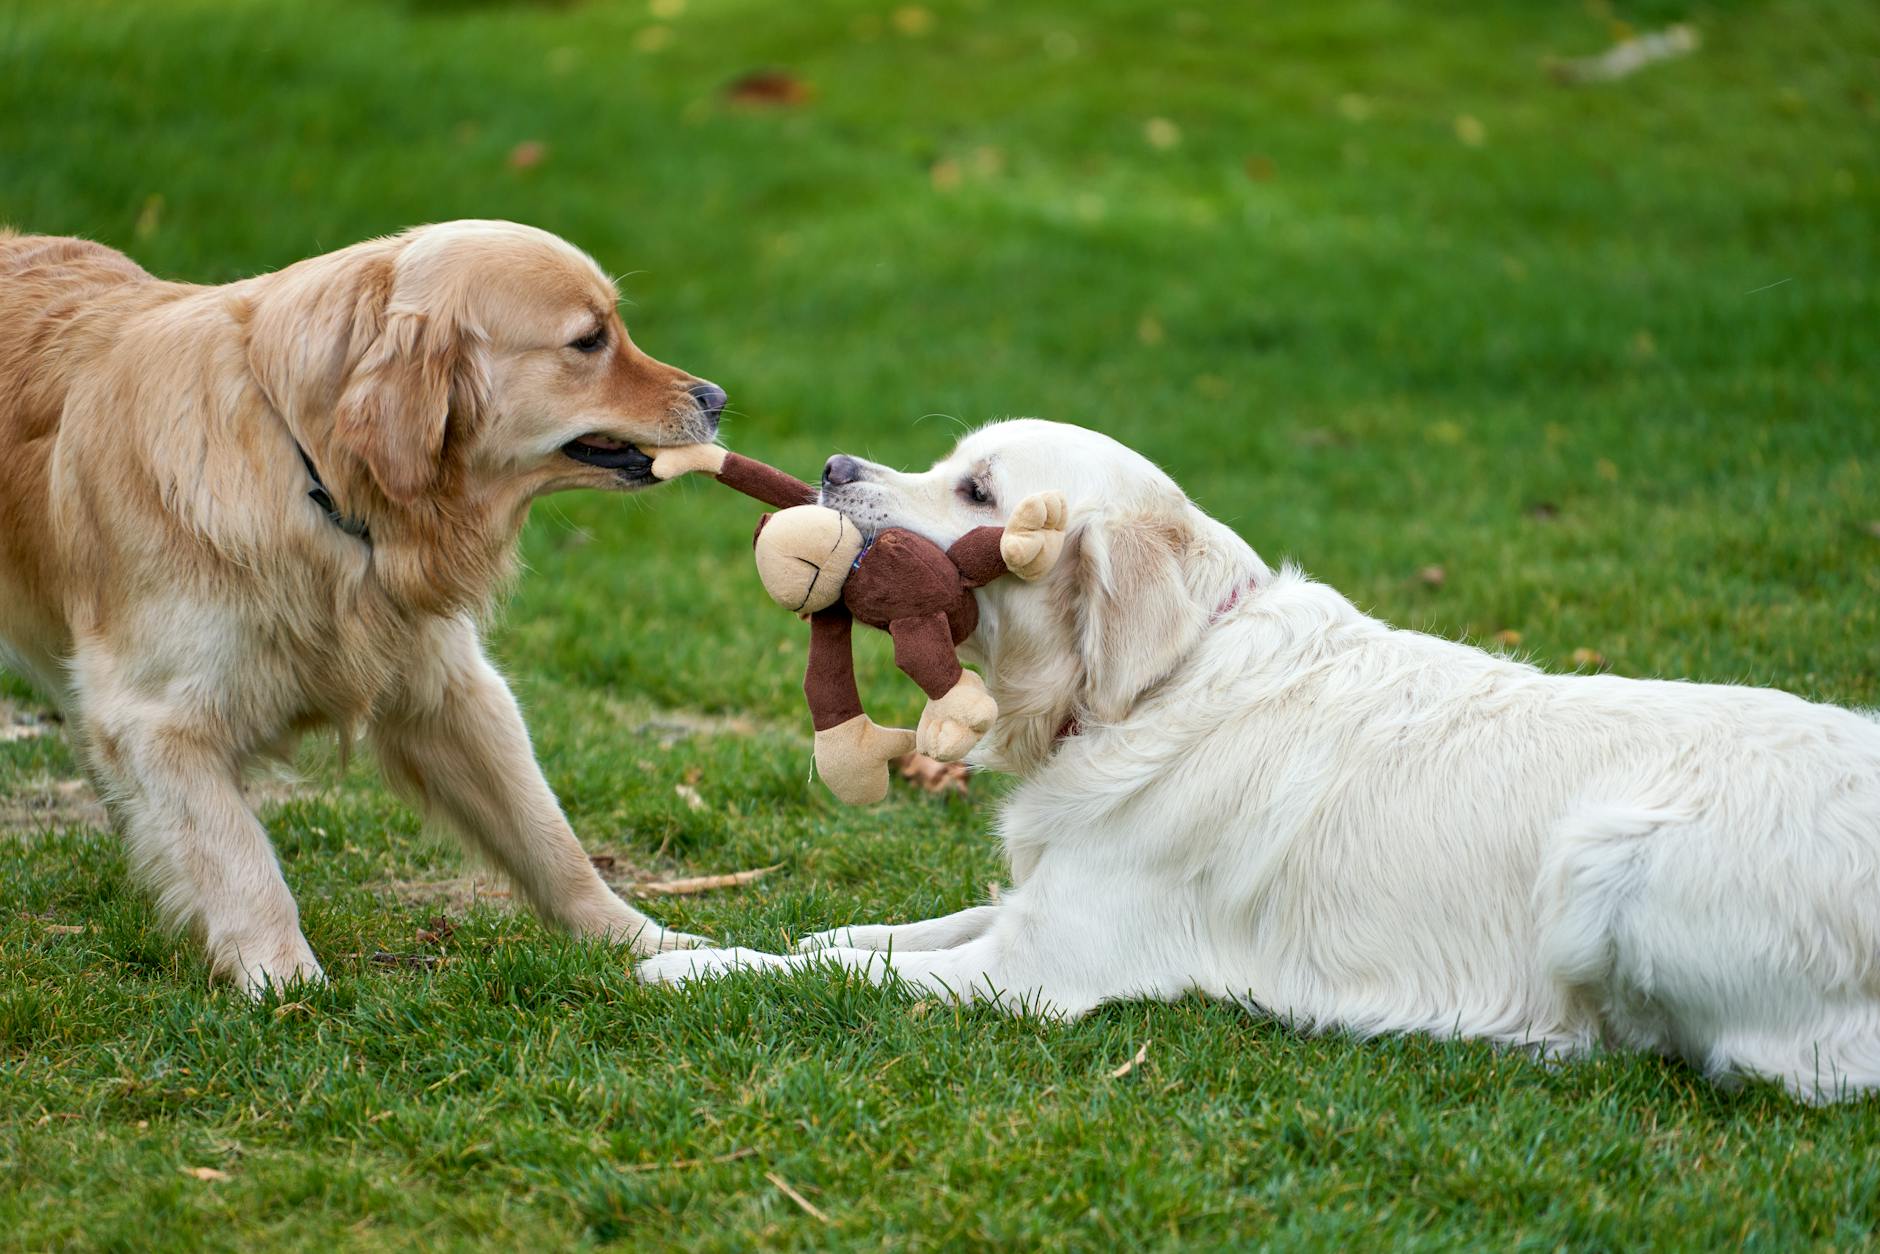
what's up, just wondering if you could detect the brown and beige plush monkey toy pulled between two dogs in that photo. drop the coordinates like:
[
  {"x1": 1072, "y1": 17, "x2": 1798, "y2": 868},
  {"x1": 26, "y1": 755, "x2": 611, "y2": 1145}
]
[{"x1": 647, "y1": 444, "x2": 1064, "y2": 805}]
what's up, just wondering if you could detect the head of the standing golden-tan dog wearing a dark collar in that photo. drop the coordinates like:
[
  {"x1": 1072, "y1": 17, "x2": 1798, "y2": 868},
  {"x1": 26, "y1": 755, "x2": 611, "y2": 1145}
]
[{"x1": 250, "y1": 222, "x2": 724, "y2": 508}]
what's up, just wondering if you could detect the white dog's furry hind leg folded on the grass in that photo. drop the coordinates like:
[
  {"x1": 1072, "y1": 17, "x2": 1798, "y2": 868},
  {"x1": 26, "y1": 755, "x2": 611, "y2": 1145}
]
[{"x1": 1536, "y1": 807, "x2": 1880, "y2": 1102}]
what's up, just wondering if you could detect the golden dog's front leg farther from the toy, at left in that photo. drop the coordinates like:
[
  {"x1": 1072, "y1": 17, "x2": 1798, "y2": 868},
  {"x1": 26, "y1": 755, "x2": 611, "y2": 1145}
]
[{"x1": 79, "y1": 654, "x2": 321, "y2": 996}]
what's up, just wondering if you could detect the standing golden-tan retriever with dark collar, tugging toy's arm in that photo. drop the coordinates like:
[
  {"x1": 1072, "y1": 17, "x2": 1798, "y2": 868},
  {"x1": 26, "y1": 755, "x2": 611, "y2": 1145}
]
[{"x1": 0, "y1": 222, "x2": 724, "y2": 993}]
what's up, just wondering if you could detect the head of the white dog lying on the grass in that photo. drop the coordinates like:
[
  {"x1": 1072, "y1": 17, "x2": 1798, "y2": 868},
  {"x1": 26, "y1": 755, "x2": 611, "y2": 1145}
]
[{"x1": 822, "y1": 419, "x2": 1265, "y2": 773}]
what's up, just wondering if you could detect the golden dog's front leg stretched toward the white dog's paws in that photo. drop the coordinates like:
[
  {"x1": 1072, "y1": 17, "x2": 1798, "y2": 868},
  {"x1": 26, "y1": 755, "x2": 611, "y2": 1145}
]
[{"x1": 372, "y1": 622, "x2": 699, "y2": 953}]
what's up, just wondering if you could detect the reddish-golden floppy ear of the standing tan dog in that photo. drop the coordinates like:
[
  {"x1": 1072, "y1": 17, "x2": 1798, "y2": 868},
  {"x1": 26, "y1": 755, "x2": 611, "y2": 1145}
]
[{"x1": 333, "y1": 310, "x2": 489, "y2": 504}]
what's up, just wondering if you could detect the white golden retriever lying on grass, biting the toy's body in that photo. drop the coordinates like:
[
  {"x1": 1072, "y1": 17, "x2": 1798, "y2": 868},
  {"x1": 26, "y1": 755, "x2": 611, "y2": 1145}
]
[{"x1": 639, "y1": 421, "x2": 1880, "y2": 1100}]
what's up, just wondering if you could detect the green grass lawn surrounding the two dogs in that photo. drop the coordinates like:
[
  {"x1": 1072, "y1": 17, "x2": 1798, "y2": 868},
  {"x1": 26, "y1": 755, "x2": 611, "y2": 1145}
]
[{"x1": 0, "y1": 0, "x2": 1880, "y2": 1248}]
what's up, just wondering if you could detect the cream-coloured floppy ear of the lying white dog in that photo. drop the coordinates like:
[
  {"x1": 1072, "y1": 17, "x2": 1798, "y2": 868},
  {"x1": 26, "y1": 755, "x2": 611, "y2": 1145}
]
[{"x1": 1066, "y1": 502, "x2": 1207, "y2": 722}]
